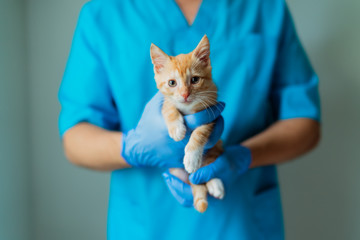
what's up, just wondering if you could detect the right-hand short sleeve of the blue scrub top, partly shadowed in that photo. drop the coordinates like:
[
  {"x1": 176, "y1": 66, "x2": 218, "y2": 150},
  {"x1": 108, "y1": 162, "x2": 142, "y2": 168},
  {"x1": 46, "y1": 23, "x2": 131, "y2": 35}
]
[{"x1": 271, "y1": 4, "x2": 320, "y2": 121}]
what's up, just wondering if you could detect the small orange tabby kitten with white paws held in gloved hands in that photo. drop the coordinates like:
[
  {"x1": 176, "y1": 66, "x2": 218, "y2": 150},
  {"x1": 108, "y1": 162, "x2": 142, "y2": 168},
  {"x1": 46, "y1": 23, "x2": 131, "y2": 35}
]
[{"x1": 150, "y1": 35, "x2": 225, "y2": 212}]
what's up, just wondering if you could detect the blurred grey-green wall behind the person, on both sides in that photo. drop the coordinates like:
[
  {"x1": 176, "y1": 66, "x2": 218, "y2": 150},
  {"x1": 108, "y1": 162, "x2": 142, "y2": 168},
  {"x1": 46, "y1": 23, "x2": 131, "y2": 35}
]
[{"x1": 0, "y1": 0, "x2": 360, "y2": 240}]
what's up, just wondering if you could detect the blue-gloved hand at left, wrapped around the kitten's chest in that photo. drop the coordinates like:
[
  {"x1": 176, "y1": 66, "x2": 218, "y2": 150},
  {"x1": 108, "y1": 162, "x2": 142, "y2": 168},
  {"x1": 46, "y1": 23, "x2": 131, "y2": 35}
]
[{"x1": 122, "y1": 92, "x2": 224, "y2": 168}]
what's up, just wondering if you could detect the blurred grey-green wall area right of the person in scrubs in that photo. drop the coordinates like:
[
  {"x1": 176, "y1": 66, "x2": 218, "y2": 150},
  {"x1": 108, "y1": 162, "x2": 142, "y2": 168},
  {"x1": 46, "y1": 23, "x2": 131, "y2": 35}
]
[{"x1": 280, "y1": 0, "x2": 360, "y2": 240}]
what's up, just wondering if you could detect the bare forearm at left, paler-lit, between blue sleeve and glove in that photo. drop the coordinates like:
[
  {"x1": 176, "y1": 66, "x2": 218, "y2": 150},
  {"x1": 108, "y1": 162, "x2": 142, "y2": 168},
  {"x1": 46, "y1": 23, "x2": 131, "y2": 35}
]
[{"x1": 63, "y1": 123, "x2": 130, "y2": 171}]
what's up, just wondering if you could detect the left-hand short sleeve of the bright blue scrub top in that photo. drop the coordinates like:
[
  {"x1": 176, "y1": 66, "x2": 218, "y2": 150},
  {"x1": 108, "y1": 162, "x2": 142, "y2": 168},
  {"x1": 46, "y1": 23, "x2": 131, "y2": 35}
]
[{"x1": 58, "y1": 2, "x2": 119, "y2": 137}]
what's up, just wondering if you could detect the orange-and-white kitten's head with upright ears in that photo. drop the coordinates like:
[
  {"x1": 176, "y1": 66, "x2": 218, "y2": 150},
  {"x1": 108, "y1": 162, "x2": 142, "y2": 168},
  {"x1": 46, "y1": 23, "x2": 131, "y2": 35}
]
[{"x1": 150, "y1": 36, "x2": 217, "y2": 108}]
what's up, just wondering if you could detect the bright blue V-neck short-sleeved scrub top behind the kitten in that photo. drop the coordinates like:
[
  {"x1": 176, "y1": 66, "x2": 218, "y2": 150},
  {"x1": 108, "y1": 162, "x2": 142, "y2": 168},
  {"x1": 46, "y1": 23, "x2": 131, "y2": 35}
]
[{"x1": 59, "y1": 0, "x2": 320, "y2": 240}]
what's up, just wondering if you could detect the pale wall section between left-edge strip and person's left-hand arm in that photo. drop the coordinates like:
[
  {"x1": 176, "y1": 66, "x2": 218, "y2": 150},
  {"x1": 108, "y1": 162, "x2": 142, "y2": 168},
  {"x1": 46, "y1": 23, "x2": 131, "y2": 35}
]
[{"x1": 27, "y1": 0, "x2": 109, "y2": 240}]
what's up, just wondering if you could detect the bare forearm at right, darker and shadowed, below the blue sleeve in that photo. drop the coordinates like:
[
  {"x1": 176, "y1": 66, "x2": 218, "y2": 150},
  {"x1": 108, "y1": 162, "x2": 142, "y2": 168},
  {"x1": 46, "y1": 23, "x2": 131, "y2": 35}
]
[{"x1": 242, "y1": 118, "x2": 320, "y2": 168}]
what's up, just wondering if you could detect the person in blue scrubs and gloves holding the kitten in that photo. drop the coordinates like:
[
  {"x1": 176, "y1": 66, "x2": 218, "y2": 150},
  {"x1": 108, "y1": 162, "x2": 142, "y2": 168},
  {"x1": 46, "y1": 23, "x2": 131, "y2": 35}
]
[{"x1": 59, "y1": 0, "x2": 320, "y2": 240}]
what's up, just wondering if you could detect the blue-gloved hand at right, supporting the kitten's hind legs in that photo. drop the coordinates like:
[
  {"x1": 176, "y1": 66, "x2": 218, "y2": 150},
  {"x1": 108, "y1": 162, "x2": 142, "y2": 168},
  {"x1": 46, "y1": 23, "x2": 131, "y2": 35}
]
[{"x1": 163, "y1": 145, "x2": 252, "y2": 207}]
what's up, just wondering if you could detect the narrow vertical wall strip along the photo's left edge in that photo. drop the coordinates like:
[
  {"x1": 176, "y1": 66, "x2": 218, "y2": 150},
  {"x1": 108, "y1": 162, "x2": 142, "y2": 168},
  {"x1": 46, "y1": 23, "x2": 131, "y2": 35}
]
[{"x1": 0, "y1": 0, "x2": 30, "y2": 240}]
